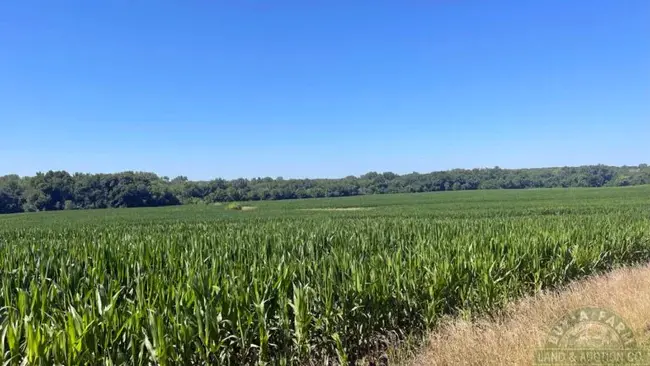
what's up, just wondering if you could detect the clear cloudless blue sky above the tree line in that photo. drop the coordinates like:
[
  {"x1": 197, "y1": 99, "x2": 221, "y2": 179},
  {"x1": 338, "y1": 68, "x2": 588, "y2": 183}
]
[{"x1": 0, "y1": 0, "x2": 650, "y2": 179}]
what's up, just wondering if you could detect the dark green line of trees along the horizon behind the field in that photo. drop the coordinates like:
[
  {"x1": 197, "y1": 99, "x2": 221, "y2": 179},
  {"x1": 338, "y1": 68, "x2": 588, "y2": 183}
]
[{"x1": 0, "y1": 164, "x2": 650, "y2": 213}]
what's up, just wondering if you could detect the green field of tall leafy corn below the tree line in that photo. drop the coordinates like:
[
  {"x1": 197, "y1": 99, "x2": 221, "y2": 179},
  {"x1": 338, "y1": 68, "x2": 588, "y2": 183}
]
[{"x1": 0, "y1": 186, "x2": 650, "y2": 365}]
